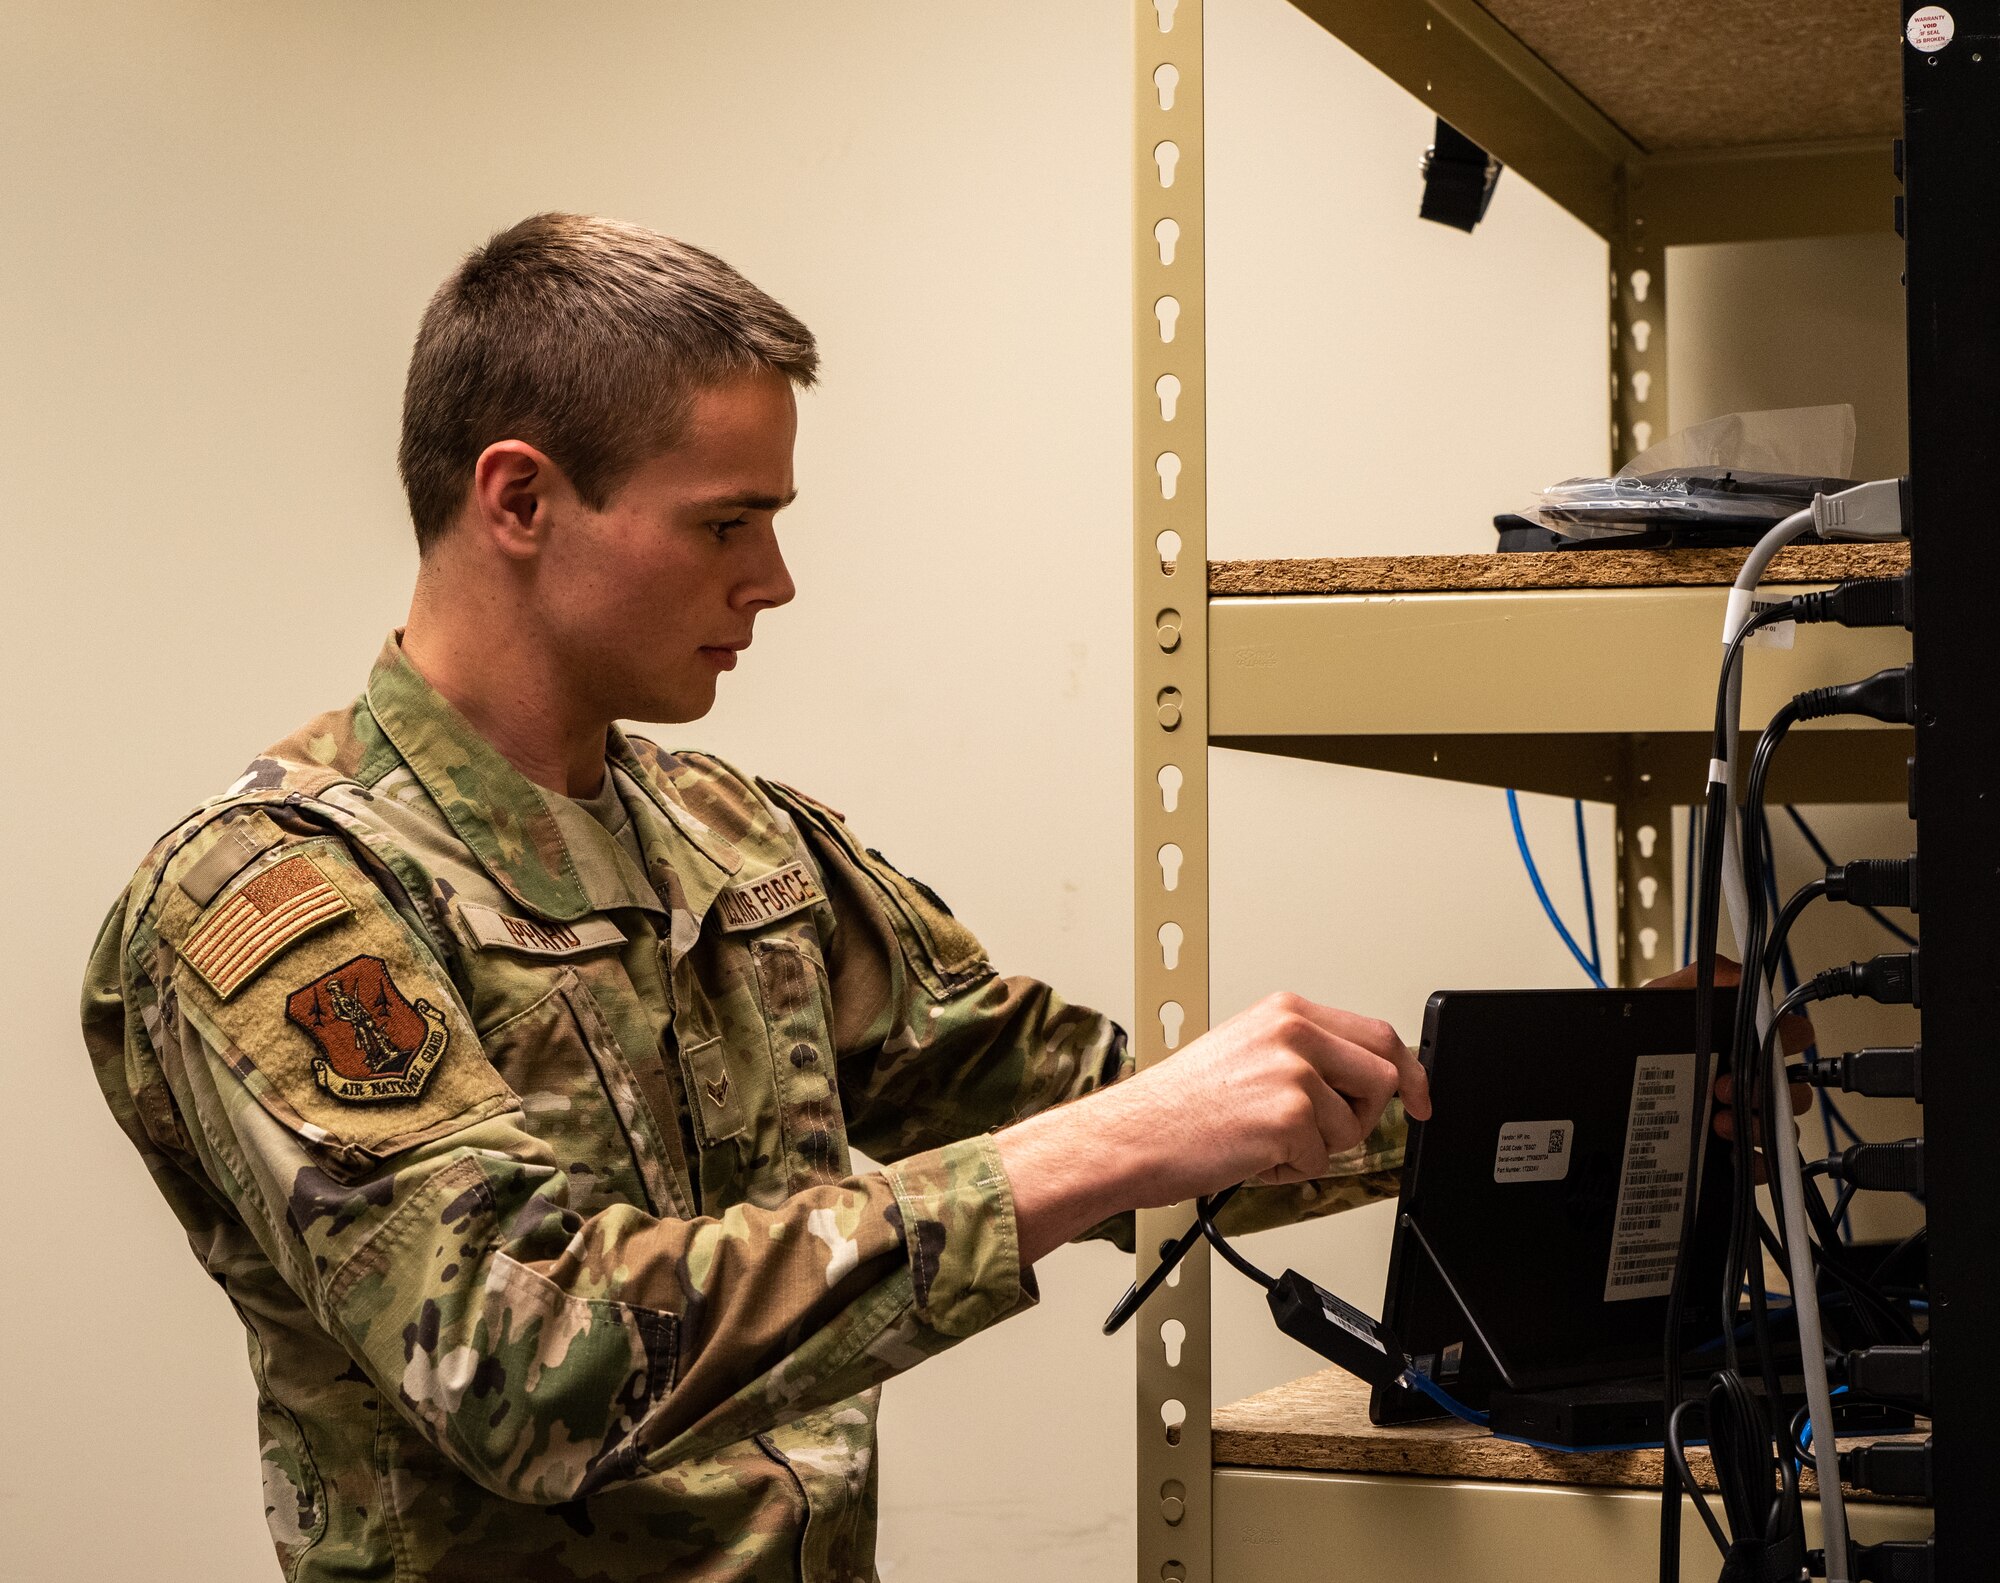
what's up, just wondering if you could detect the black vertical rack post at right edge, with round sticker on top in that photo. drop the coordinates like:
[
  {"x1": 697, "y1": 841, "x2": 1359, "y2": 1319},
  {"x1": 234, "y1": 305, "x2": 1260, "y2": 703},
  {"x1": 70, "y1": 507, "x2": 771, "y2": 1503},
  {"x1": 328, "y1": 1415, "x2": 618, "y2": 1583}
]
[{"x1": 1902, "y1": 0, "x2": 2000, "y2": 1579}]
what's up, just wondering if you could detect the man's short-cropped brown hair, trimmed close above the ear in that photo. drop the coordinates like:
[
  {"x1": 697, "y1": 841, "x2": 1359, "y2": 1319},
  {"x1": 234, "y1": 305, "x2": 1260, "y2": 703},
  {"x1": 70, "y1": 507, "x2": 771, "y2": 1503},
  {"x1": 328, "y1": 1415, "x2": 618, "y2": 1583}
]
[{"x1": 398, "y1": 214, "x2": 820, "y2": 554}]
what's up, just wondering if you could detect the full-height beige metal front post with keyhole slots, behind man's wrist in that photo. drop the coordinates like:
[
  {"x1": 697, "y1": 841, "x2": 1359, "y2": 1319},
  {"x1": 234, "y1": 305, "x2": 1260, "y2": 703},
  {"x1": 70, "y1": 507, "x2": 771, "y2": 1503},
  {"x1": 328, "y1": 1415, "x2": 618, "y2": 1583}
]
[{"x1": 1132, "y1": 0, "x2": 1210, "y2": 1583}]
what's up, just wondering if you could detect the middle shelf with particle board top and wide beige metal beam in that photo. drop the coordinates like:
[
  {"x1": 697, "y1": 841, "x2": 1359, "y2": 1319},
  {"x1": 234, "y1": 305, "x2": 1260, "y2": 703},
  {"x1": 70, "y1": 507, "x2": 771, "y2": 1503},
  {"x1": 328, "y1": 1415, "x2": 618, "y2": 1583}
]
[{"x1": 1208, "y1": 546, "x2": 1910, "y2": 801}]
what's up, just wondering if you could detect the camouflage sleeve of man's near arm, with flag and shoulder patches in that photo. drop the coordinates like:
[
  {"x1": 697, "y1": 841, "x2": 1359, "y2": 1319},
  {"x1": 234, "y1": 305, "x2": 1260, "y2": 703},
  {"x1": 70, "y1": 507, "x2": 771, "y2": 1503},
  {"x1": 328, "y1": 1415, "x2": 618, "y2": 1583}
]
[{"x1": 84, "y1": 815, "x2": 1032, "y2": 1503}]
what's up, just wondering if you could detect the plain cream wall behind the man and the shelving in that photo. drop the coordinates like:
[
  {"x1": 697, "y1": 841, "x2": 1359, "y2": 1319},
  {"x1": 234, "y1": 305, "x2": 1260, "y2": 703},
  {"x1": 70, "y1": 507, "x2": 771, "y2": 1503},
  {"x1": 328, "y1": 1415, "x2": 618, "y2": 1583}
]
[{"x1": 0, "y1": 0, "x2": 1904, "y2": 1583}]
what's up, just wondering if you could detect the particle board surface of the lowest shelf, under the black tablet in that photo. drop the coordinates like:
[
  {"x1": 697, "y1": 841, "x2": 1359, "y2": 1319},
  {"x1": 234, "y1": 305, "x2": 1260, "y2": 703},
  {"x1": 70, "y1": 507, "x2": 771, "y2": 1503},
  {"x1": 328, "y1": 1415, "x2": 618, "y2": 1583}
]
[{"x1": 1212, "y1": 1369, "x2": 1912, "y2": 1501}]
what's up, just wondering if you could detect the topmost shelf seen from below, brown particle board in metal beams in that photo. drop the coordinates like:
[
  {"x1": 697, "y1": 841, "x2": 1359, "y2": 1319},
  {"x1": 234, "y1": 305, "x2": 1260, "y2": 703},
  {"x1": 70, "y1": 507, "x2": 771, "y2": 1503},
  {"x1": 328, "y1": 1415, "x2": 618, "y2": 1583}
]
[{"x1": 1294, "y1": 0, "x2": 1902, "y2": 246}]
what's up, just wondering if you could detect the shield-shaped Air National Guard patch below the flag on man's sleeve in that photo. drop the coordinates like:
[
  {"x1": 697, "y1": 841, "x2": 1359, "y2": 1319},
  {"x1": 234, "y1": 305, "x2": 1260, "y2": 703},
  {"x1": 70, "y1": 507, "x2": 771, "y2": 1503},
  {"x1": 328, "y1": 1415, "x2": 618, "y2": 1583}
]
[{"x1": 284, "y1": 955, "x2": 450, "y2": 1103}]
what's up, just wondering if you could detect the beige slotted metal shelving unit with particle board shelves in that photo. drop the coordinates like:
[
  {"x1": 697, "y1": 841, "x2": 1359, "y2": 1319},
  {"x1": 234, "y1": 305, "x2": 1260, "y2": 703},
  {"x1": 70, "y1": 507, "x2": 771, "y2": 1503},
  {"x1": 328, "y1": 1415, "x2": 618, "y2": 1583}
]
[{"x1": 1132, "y1": 0, "x2": 1908, "y2": 1583}]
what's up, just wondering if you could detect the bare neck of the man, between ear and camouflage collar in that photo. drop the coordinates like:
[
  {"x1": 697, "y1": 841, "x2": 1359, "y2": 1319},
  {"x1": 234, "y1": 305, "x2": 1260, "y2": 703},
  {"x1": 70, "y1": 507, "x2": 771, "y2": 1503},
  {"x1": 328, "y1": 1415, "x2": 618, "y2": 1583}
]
[{"x1": 402, "y1": 584, "x2": 610, "y2": 797}]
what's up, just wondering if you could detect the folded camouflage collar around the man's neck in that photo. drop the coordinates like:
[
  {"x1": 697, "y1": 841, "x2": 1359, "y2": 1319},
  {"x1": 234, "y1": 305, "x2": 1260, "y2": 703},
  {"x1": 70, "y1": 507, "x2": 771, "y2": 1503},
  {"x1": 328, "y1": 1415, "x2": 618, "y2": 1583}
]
[{"x1": 364, "y1": 634, "x2": 742, "y2": 927}]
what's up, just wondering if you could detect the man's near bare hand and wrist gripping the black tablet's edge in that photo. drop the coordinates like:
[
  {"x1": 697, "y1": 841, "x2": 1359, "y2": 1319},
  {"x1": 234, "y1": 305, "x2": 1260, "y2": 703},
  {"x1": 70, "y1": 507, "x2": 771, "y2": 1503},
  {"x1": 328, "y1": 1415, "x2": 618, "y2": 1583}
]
[{"x1": 996, "y1": 993, "x2": 1430, "y2": 1265}]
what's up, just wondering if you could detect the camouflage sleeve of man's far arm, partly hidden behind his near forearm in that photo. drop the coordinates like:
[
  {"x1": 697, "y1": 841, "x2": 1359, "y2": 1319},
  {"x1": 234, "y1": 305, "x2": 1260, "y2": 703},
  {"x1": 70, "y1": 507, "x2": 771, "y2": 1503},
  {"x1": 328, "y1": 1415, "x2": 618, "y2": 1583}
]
[{"x1": 762, "y1": 782, "x2": 1132, "y2": 1159}]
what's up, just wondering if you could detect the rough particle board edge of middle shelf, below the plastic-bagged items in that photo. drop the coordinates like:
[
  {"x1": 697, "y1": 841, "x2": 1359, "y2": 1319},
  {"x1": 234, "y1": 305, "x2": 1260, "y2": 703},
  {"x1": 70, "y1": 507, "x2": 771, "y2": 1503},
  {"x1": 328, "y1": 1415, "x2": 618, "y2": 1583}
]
[{"x1": 1208, "y1": 544, "x2": 1910, "y2": 600}]
